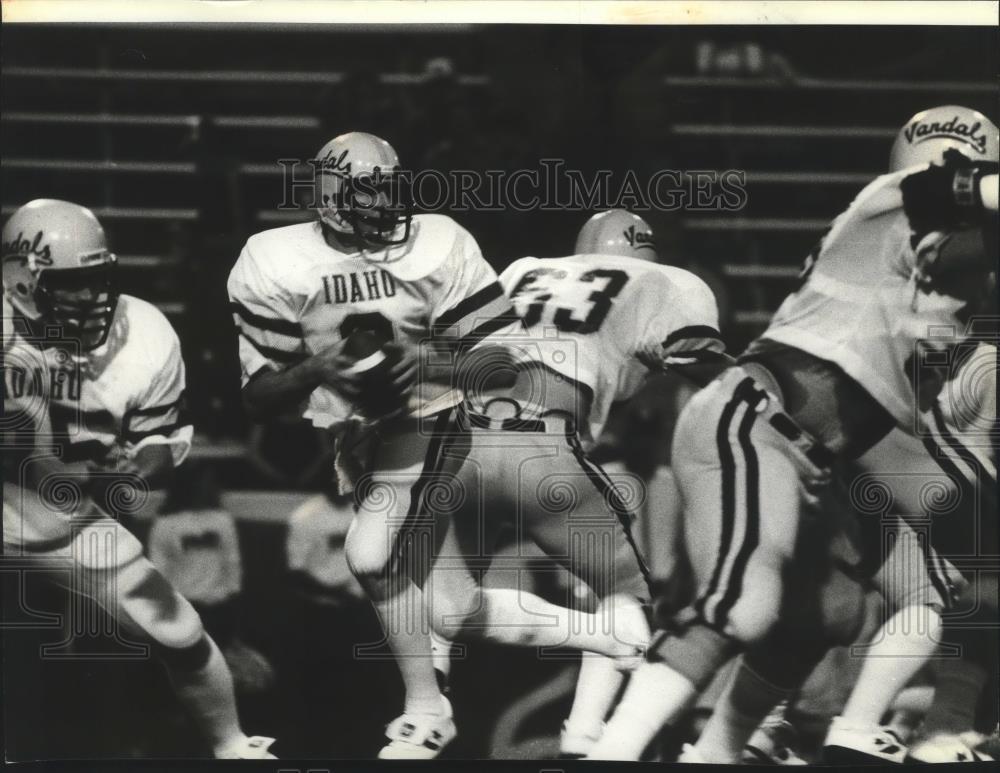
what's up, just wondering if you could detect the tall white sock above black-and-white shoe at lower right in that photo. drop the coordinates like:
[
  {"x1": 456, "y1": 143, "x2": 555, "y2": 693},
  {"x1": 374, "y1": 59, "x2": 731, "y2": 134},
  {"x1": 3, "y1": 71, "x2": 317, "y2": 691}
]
[{"x1": 841, "y1": 604, "x2": 941, "y2": 727}]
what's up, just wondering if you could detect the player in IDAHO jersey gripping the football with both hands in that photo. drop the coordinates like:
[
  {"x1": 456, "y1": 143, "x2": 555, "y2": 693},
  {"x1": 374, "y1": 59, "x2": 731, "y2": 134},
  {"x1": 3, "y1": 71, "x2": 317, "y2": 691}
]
[{"x1": 229, "y1": 132, "x2": 648, "y2": 759}]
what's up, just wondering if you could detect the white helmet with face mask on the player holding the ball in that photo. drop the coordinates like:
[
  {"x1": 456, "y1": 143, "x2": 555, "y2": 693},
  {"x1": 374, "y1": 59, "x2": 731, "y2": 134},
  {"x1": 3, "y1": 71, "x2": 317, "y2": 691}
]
[{"x1": 314, "y1": 132, "x2": 413, "y2": 246}]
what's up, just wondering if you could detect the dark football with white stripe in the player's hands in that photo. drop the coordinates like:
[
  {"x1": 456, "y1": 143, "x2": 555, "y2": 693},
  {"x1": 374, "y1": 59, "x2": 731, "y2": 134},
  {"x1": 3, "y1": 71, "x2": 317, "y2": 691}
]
[{"x1": 343, "y1": 330, "x2": 412, "y2": 419}]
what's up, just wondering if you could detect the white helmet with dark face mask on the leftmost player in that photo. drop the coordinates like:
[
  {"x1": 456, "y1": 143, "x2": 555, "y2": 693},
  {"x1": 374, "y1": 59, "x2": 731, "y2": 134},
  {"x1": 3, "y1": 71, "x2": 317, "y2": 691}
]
[{"x1": 3, "y1": 199, "x2": 118, "y2": 350}]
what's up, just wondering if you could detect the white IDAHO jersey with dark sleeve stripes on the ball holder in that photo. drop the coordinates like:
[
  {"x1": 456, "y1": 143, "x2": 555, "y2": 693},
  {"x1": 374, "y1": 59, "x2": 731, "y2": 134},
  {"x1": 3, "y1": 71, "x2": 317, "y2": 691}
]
[{"x1": 229, "y1": 215, "x2": 520, "y2": 427}]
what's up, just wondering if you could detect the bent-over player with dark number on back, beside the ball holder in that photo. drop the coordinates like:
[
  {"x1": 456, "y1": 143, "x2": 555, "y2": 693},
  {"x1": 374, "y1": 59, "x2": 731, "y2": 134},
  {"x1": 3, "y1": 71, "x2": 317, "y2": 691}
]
[{"x1": 410, "y1": 205, "x2": 727, "y2": 756}]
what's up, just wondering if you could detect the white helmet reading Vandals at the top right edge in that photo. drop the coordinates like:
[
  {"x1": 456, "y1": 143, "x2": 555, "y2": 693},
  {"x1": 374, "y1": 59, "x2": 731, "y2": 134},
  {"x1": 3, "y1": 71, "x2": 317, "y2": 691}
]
[{"x1": 889, "y1": 105, "x2": 1000, "y2": 172}]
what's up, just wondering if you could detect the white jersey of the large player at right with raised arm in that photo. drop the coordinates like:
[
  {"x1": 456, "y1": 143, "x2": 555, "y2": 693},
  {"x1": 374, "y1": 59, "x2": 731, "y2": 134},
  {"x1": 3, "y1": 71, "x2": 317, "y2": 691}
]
[{"x1": 751, "y1": 168, "x2": 984, "y2": 431}]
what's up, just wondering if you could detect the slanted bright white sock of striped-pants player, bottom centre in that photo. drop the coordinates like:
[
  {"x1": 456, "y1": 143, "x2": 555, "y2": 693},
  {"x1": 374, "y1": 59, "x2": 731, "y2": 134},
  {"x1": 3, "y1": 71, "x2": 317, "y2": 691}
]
[{"x1": 587, "y1": 663, "x2": 698, "y2": 760}]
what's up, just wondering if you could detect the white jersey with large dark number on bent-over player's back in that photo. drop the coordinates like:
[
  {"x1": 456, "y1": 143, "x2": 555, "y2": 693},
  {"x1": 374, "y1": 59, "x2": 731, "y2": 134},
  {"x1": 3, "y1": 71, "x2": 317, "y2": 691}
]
[{"x1": 500, "y1": 255, "x2": 725, "y2": 438}]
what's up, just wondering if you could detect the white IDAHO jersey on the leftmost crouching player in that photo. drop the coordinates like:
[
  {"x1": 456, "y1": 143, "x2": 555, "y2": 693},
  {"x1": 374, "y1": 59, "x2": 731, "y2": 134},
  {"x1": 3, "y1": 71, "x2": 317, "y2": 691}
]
[{"x1": 3, "y1": 295, "x2": 193, "y2": 547}]
